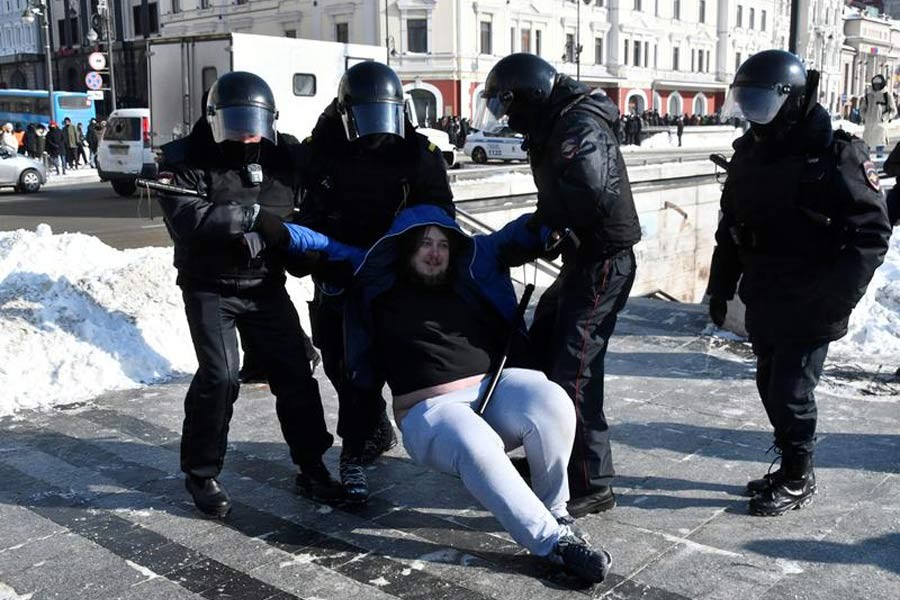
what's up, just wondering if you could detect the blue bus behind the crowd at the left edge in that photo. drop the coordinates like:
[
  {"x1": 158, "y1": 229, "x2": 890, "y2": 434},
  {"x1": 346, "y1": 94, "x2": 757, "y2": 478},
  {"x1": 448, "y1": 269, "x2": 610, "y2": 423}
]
[{"x1": 0, "y1": 90, "x2": 97, "y2": 127}]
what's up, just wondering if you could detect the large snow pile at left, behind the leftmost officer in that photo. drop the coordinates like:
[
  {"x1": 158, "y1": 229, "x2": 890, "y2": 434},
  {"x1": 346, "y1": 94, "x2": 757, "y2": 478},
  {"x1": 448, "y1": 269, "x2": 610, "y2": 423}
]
[{"x1": 0, "y1": 225, "x2": 310, "y2": 415}]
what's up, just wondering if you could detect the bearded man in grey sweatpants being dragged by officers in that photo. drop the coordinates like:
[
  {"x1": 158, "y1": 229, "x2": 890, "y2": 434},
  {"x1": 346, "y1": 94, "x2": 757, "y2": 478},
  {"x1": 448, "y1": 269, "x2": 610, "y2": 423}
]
[{"x1": 255, "y1": 205, "x2": 610, "y2": 582}]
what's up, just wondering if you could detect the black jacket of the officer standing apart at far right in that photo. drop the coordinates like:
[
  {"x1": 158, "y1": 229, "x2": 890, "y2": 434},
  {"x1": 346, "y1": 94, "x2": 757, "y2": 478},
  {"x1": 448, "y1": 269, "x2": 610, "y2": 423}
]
[{"x1": 708, "y1": 105, "x2": 891, "y2": 343}]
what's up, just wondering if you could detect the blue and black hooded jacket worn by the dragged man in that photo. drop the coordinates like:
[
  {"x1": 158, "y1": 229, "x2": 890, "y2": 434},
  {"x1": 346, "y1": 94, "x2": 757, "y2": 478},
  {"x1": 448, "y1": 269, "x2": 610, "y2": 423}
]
[{"x1": 285, "y1": 205, "x2": 550, "y2": 389}]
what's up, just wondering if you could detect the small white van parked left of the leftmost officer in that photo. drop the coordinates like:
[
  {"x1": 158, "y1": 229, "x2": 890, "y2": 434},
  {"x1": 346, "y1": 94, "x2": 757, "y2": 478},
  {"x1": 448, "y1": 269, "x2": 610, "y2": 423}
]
[{"x1": 97, "y1": 108, "x2": 157, "y2": 196}]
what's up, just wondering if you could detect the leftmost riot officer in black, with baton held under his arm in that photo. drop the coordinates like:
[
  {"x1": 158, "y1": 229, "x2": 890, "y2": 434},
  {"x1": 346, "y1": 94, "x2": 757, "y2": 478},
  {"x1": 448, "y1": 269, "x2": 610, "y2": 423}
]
[{"x1": 159, "y1": 71, "x2": 341, "y2": 517}]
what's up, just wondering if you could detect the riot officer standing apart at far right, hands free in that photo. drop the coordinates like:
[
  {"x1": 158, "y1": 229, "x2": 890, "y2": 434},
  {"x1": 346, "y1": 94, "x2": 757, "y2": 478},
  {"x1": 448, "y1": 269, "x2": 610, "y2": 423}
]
[{"x1": 708, "y1": 50, "x2": 891, "y2": 516}]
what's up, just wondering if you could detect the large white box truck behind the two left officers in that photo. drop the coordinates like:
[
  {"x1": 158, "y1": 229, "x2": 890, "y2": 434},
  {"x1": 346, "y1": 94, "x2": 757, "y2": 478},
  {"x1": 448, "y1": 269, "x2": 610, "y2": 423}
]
[{"x1": 147, "y1": 33, "x2": 455, "y2": 166}]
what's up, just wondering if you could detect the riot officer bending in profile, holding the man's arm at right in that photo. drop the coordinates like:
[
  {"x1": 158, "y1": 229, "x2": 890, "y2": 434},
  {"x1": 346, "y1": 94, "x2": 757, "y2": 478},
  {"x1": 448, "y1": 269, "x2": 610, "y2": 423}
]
[{"x1": 476, "y1": 54, "x2": 641, "y2": 517}]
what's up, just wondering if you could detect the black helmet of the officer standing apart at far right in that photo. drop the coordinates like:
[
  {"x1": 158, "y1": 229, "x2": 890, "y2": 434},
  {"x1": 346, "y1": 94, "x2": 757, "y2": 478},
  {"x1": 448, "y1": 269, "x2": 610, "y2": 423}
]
[{"x1": 722, "y1": 50, "x2": 819, "y2": 134}]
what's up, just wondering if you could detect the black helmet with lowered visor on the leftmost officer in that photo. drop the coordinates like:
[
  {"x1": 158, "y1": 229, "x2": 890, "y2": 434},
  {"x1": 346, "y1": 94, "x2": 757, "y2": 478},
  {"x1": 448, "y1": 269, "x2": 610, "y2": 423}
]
[{"x1": 206, "y1": 71, "x2": 278, "y2": 144}]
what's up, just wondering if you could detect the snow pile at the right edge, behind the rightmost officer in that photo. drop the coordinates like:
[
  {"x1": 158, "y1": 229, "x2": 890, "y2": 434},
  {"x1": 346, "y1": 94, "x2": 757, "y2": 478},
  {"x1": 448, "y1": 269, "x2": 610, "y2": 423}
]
[{"x1": 832, "y1": 233, "x2": 900, "y2": 363}]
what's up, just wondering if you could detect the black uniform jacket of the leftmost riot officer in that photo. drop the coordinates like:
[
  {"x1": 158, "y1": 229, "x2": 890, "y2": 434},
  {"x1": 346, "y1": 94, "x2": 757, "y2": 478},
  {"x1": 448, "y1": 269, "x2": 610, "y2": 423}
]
[{"x1": 159, "y1": 120, "x2": 299, "y2": 293}]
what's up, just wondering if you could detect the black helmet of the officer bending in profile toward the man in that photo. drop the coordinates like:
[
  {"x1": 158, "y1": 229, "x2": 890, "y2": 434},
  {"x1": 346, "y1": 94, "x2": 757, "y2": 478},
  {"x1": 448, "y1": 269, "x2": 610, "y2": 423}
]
[{"x1": 472, "y1": 52, "x2": 556, "y2": 133}]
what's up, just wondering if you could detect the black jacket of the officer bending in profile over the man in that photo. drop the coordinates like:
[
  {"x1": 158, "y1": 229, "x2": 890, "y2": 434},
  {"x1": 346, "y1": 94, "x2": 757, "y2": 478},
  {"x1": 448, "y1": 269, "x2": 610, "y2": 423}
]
[{"x1": 527, "y1": 75, "x2": 641, "y2": 260}]
